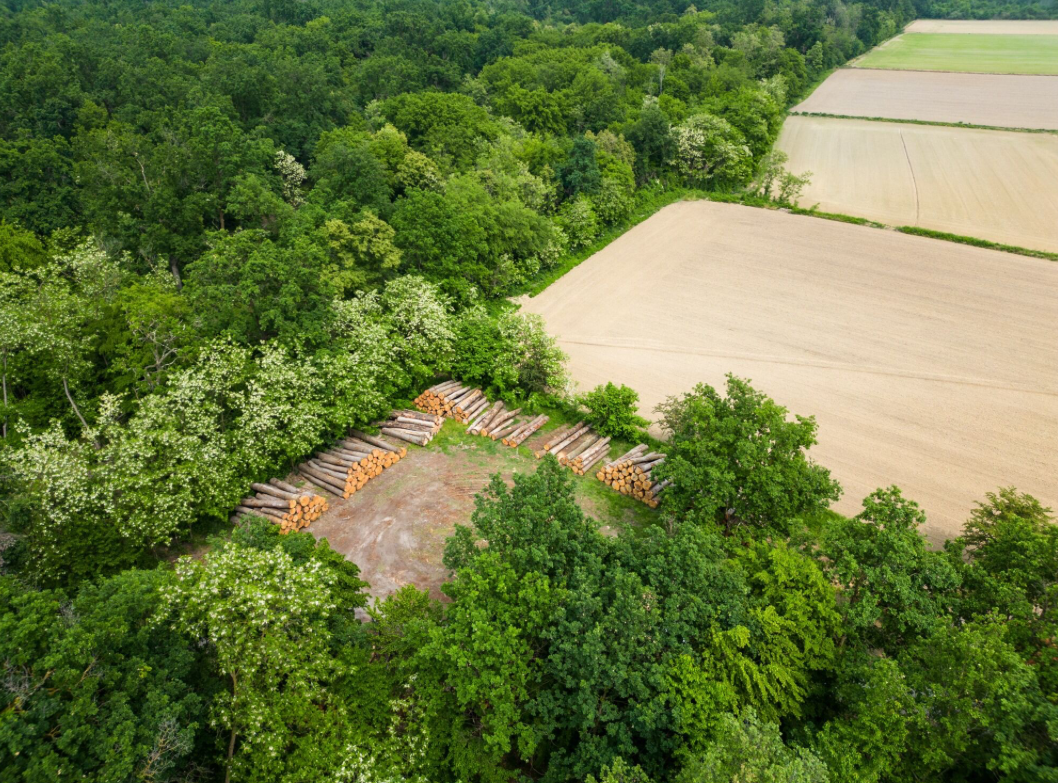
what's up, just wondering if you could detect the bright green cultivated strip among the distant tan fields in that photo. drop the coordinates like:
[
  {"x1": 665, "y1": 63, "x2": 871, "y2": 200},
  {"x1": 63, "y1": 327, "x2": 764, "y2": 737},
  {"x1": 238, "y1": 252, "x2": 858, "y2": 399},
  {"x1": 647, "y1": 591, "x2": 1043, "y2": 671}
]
[{"x1": 854, "y1": 33, "x2": 1058, "y2": 74}]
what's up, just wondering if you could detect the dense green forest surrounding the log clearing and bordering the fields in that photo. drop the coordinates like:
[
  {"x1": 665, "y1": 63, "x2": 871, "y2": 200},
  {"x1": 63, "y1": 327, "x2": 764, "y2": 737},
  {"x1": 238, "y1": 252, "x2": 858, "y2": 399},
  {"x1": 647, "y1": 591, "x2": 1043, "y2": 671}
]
[{"x1": 0, "y1": 0, "x2": 1058, "y2": 783}]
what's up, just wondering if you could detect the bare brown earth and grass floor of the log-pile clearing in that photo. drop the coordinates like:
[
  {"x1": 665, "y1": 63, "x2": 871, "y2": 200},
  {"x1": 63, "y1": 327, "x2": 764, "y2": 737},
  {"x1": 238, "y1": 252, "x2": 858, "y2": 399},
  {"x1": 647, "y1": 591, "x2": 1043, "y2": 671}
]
[{"x1": 308, "y1": 421, "x2": 657, "y2": 599}]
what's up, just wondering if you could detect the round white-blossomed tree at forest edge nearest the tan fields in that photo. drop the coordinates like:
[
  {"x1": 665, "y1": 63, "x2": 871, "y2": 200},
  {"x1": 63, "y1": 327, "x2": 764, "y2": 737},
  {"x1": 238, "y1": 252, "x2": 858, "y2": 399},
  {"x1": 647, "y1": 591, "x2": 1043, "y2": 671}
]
[{"x1": 674, "y1": 113, "x2": 753, "y2": 187}]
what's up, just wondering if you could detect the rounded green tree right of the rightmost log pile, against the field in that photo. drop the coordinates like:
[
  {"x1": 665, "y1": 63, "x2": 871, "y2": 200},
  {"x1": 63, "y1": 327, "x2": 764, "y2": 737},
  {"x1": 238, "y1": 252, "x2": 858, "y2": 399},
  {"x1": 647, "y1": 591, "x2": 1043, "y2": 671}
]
[{"x1": 658, "y1": 376, "x2": 840, "y2": 530}]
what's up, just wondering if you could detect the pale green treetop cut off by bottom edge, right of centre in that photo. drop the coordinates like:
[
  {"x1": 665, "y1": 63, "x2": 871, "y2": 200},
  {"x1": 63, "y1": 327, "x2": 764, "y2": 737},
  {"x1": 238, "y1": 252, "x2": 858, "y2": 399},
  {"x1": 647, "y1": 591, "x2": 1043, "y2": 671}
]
[{"x1": 676, "y1": 710, "x2": 831, "y2": 783}]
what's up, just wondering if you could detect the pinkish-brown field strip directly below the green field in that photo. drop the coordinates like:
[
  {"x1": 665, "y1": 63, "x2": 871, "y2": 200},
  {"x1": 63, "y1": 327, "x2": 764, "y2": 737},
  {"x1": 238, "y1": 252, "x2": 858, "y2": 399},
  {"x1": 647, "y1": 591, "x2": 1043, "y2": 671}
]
[{"x1": 792, "y1": 68, "x2": 1058, "y2": 130}]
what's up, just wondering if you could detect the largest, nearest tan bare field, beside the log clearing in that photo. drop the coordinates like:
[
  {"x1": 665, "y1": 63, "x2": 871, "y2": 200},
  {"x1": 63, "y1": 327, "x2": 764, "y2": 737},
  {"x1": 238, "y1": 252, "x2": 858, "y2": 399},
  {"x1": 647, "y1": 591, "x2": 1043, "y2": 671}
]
[{"x1": 522, "y1": 201, "x2": 1058, "y2": 542}]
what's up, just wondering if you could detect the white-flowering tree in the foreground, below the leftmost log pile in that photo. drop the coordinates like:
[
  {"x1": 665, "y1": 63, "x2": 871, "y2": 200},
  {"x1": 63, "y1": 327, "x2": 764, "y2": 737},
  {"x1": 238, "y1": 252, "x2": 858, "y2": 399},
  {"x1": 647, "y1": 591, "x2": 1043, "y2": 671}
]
[{"x1": 159, "y1": 545, "x2": 348, "y2": 781}]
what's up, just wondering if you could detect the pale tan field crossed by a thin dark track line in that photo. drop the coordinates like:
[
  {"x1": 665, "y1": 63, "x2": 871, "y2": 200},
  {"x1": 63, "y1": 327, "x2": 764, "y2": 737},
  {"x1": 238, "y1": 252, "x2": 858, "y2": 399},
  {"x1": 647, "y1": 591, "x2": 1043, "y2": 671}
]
[{"x1": 777, "y1": 116, "x2": 1058, "y2": 252}]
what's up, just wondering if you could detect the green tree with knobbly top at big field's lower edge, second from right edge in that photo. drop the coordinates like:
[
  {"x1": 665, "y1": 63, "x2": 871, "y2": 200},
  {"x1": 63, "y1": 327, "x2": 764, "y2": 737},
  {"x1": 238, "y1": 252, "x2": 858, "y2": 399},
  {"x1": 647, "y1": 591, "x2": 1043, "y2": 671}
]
[{"x1": 819, "y1": 487, "x2": 960, "y2": 653}]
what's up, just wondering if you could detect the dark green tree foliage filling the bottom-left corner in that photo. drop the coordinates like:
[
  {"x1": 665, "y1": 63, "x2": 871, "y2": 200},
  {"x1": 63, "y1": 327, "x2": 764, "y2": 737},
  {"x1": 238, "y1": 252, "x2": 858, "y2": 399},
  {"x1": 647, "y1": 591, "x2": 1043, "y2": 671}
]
[{"x1": 0, "y1": 570, "x2": 211, "y2": 783}]
